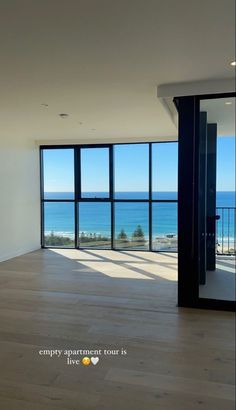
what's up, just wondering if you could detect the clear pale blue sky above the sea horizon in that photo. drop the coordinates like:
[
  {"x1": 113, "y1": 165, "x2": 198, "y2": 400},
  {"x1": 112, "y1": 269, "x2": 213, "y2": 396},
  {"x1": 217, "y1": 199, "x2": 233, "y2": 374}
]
[{"x1": 44, "y1": 137, "x2": 235, "y2": 192}]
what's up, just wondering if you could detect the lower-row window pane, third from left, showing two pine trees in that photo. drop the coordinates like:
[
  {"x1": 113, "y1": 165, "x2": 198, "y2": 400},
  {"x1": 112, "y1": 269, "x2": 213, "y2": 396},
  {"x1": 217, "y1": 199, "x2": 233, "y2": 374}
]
[{"x1": 115, "y1": 202, "x2": 149, "y2": 249}]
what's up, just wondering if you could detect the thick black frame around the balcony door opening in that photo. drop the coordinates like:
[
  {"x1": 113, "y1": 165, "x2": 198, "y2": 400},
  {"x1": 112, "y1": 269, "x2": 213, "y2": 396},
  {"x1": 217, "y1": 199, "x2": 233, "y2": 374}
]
[{"x1": 174, "y1": 92, "x2": 236, "y2": 311}]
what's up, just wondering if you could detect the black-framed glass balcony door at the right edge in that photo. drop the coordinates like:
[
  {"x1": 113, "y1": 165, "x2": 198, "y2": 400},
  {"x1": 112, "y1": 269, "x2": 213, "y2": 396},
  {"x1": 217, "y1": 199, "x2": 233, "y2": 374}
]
[{"x1": 175, "y1": 93, "x2": 236, "y2": 310}]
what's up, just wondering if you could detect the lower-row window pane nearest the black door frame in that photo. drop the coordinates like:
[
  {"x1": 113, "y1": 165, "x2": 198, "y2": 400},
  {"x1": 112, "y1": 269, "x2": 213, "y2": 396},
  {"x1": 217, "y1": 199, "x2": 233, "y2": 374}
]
[{"x1": 152, "y1": 202, "x2": 178, "y2": 251}]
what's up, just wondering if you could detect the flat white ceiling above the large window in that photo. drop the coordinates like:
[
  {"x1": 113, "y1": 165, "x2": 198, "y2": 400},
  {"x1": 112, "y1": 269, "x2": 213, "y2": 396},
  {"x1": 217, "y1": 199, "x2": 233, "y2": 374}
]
[{"x1": 0, "y1": 0, "x2": 235, "y2": 142}]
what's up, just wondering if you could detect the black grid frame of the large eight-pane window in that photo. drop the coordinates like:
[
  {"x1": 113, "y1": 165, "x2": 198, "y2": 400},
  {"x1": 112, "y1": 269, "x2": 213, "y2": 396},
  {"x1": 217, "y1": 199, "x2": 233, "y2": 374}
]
[{"x1": 39, "y1": 140, "x2": 178, "y2": 253}]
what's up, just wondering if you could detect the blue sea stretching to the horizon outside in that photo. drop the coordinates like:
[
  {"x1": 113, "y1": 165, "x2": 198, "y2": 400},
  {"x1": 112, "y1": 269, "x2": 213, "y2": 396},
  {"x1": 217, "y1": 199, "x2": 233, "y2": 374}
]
[{"x1": 44, "y1": 192, "x2": 235, "y2": 241}]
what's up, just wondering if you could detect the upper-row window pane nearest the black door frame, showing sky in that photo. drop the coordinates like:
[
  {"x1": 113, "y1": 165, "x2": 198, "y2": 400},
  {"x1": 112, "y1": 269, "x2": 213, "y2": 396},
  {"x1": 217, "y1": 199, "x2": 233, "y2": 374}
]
[{"x1": 152, "y1": 142, "x2": 178, "y2": 199}]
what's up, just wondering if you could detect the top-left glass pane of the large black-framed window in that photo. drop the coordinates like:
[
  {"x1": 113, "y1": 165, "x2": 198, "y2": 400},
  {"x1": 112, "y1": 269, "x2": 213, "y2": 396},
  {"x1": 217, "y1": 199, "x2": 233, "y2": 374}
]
[{"x1": 43, "y1": 148, "x2": 74, "y2": 199}]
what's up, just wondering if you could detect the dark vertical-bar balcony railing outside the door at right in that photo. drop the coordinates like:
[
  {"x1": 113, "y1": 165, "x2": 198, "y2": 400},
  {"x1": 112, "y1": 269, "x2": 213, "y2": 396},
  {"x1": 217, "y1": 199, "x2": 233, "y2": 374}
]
[{"x1": 216, "y1": 207, "x2": 236, "y2": 255}]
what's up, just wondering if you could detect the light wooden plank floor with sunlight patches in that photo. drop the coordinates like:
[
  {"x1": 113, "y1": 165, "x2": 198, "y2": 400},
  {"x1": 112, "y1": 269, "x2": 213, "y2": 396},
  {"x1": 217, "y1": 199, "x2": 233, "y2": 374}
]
[{"x1": 0, "y1": 250, "x2": 234, "y2": 410}]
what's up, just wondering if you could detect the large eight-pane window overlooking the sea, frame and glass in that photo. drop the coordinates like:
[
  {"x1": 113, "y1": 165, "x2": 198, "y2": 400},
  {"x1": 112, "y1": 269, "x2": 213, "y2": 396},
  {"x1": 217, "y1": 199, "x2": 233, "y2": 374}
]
[{"x1": 41, "y1": 142, "x2": 178, "y2": 251}]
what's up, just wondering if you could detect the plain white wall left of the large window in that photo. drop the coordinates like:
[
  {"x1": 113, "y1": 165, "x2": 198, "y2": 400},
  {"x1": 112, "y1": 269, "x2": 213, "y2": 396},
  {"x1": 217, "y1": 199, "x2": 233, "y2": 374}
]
[{"x1": 0, "y1": 136, "x2": 40, "y2": 261}]
